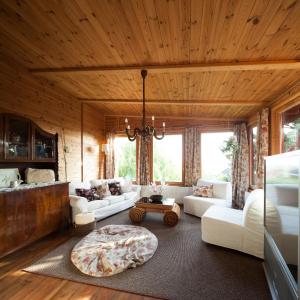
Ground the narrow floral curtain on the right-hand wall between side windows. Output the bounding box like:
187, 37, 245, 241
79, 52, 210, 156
256, 108, 269, 189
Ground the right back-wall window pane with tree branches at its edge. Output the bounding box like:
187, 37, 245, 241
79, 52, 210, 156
201, 132, 234, 181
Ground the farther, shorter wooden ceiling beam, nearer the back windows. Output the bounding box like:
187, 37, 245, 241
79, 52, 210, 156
79, 98, 264, 106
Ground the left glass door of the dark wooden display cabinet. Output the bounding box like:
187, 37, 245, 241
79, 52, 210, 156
5, 117, 30, 160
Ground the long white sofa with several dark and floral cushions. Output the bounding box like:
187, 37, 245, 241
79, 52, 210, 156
69, 179, 141, 222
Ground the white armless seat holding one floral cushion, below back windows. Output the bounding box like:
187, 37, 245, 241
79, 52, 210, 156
183, 179, 232, 217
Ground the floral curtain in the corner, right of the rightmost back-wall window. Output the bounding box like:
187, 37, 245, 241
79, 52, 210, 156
232, 123, 249, 209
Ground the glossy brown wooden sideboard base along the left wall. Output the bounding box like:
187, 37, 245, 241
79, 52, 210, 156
0, 183, 71, 257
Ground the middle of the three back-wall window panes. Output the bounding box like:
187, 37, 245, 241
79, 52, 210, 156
153, 134, 183, 182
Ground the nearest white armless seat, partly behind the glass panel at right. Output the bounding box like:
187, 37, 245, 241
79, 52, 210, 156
201, 189, 280, 258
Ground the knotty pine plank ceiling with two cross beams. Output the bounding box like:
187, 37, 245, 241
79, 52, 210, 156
0, 0, 300, 118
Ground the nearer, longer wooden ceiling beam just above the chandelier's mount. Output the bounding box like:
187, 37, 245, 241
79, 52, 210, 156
29, 60, 300, 75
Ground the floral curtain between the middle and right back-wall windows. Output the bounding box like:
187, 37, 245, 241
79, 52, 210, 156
184, 128, 201, 186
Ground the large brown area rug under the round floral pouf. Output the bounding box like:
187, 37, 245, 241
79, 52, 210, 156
25, 211, 271, 300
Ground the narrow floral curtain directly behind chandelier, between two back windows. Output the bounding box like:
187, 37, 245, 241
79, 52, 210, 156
137, 137, 150, 185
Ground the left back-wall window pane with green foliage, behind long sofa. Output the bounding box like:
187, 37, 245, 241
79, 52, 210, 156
114, 137, 136, 180
